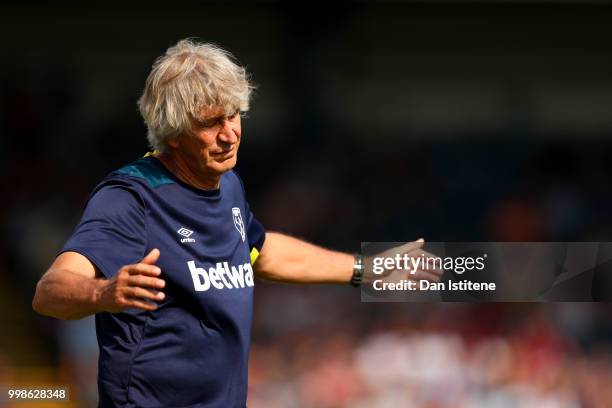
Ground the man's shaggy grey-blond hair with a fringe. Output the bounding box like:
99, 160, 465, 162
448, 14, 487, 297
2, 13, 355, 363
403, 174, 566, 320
138, 39, 254, 152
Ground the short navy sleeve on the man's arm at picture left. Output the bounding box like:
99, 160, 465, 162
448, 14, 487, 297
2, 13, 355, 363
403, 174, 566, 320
61, 185, 147, 278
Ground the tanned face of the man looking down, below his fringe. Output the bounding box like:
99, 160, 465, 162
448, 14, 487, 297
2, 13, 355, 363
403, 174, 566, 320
169, 107, 241, 177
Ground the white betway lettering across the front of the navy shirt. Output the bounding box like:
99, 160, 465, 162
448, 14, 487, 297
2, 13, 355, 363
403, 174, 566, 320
187, 261, 254, 292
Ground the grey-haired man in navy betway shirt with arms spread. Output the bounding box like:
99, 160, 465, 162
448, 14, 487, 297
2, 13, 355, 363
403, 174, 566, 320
33, 40, 437, 407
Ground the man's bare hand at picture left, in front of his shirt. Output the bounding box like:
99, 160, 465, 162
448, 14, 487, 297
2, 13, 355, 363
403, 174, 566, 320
96, 248, 166, 313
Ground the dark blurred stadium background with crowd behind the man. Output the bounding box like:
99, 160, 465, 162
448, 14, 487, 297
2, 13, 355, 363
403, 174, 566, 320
0, 1, 612, 408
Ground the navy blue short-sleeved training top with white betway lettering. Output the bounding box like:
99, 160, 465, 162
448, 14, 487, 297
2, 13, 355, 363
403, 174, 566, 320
62, 157, 265, 408
